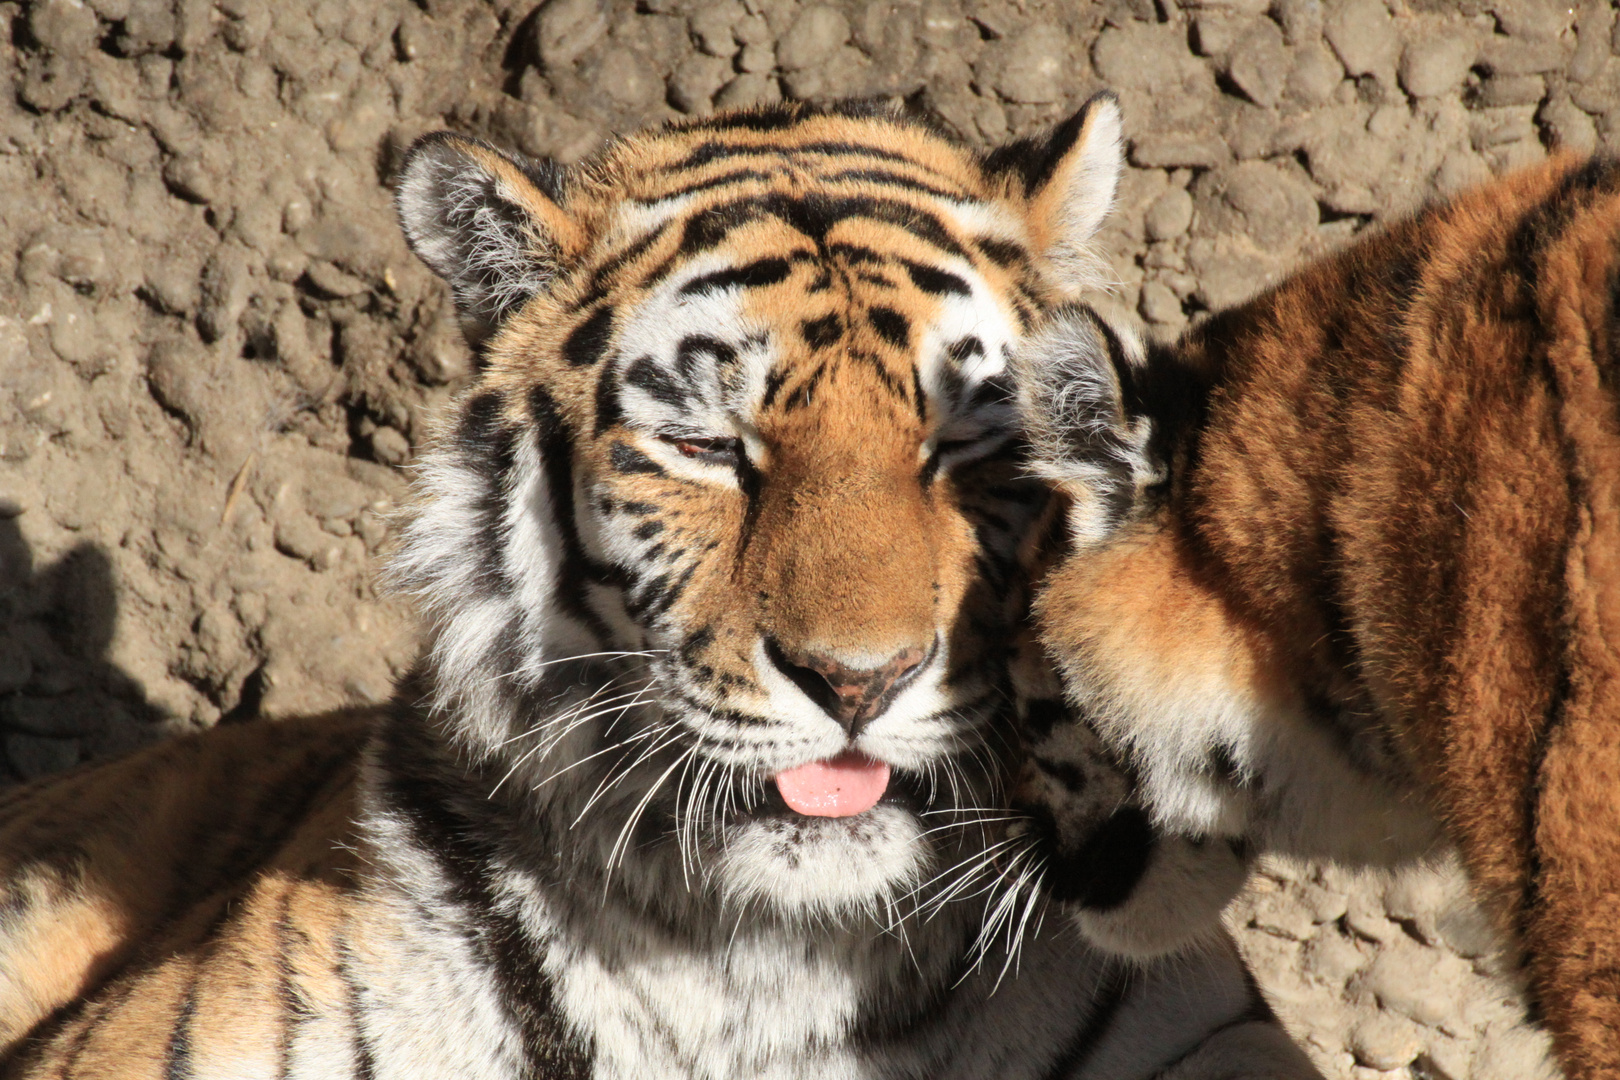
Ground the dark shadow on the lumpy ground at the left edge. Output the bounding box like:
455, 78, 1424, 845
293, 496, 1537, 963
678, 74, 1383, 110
0, 514, 160, 784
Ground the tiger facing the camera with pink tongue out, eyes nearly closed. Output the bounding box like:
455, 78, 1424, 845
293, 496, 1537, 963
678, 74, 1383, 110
0, 99, 1309, 1080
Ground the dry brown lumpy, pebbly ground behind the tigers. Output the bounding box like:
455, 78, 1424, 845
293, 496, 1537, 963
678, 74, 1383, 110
0, 0, 1600, 1080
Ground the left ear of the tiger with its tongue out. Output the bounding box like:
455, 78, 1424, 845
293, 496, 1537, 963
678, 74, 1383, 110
394, 131, 583, 348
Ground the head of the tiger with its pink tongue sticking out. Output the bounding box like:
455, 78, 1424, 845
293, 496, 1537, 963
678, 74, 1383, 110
397, 97, 1121, 918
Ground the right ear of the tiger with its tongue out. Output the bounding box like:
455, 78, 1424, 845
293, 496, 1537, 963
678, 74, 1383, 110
985, 91, 1124, 291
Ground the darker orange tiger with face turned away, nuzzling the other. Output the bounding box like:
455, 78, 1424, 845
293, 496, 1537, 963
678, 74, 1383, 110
1019, 159, 1620, 1078
